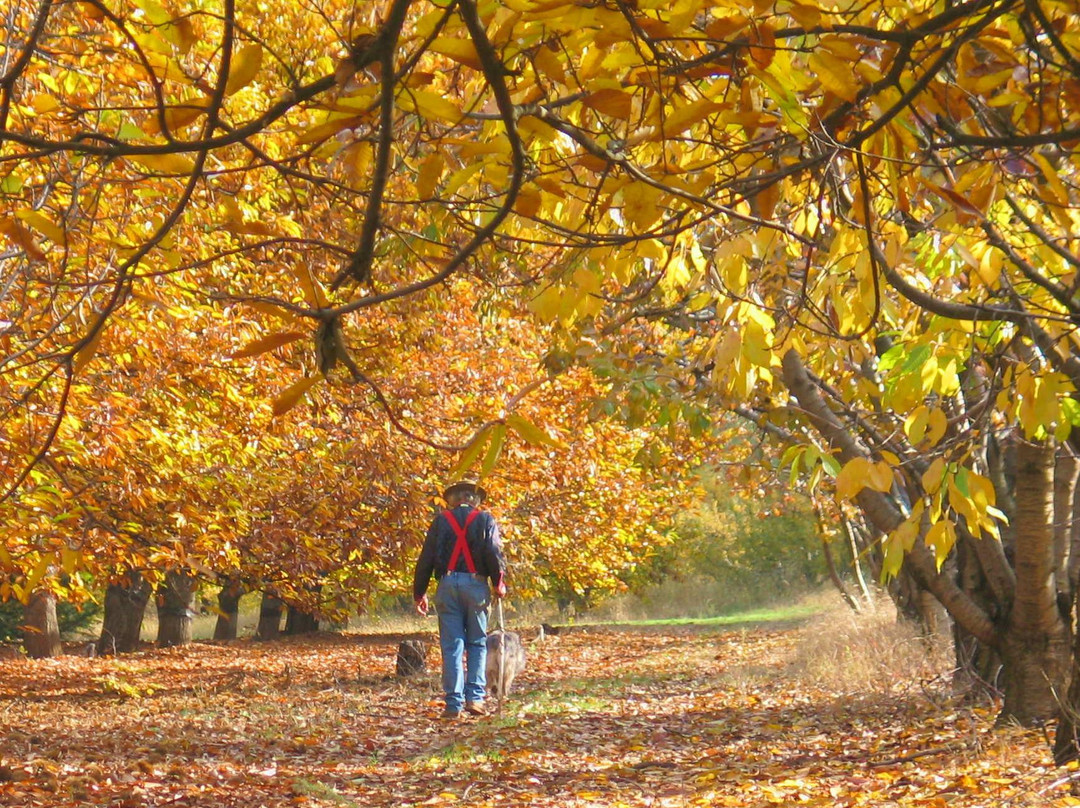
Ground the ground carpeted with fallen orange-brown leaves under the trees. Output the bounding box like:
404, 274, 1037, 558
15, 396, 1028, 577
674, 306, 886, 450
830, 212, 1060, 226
0, 630, 1080, 808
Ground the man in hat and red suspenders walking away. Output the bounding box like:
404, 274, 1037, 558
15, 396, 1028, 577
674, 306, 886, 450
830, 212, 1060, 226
413, 482, 507, 718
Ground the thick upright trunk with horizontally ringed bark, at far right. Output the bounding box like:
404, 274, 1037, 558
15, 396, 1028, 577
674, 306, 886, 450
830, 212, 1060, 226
999, 441, 1069, 726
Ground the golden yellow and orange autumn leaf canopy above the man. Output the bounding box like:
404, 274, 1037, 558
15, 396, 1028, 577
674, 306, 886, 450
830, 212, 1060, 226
6, 0, 1080, 661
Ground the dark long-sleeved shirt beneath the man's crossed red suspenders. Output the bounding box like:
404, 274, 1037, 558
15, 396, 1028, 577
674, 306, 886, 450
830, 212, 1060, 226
413, 504, 507, 600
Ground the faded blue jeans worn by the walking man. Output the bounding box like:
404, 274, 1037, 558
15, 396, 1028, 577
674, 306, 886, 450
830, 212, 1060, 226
435, 573, 491, 710
